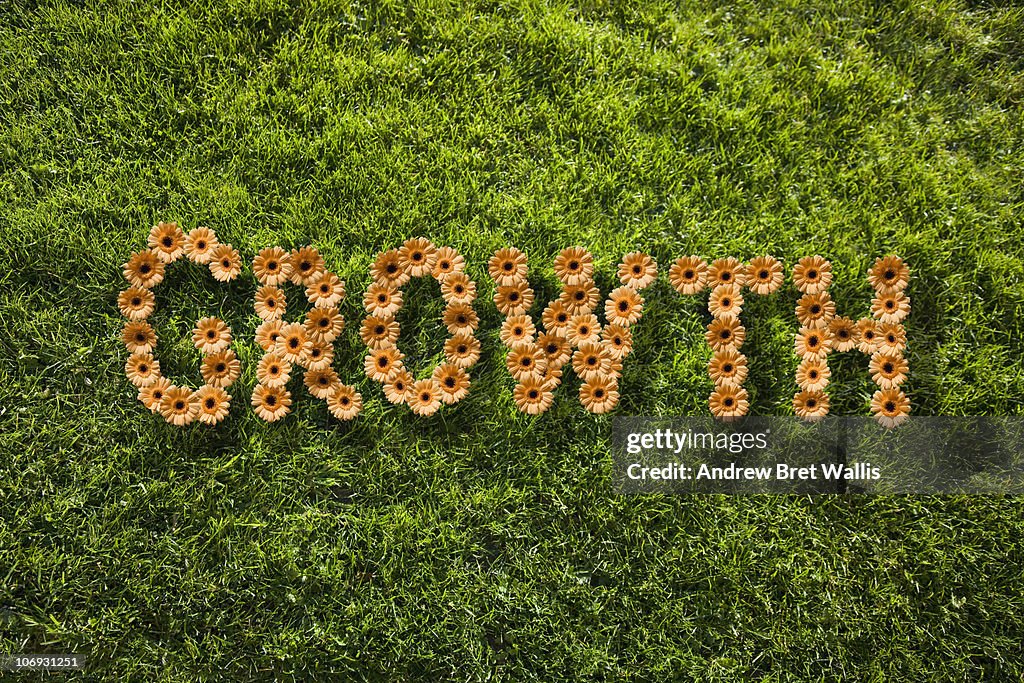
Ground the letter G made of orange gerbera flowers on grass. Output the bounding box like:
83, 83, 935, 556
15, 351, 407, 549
118, 222, 242, 427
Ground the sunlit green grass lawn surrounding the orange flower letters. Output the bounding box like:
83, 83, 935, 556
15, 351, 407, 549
0, 0, 1024, 681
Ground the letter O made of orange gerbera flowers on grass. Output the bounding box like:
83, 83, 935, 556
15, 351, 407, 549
359, 238, 480, 417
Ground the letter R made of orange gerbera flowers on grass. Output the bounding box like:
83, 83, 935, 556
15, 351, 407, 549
252, 242, 362, 422
